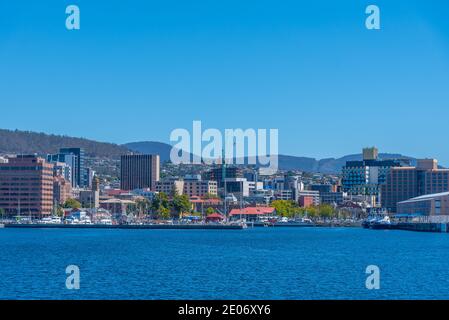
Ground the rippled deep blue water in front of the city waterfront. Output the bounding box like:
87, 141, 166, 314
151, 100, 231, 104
0, 228, 449, 299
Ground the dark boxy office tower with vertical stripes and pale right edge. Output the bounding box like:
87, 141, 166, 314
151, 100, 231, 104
120, 154, 160, 190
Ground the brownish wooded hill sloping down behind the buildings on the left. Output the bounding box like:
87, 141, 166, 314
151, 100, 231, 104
0, 129, 129, 159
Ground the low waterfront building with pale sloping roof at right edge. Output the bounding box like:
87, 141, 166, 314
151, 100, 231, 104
397, 192, 449, 216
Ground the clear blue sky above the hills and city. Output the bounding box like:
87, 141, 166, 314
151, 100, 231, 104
0, 0, 449, 165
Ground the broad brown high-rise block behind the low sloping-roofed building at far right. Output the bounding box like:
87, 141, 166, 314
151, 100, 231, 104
382, 159, 449, 212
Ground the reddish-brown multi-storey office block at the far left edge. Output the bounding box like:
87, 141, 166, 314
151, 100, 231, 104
0, 155, 53, 217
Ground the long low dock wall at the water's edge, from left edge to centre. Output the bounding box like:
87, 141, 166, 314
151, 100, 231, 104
4, 223, 245, 230
